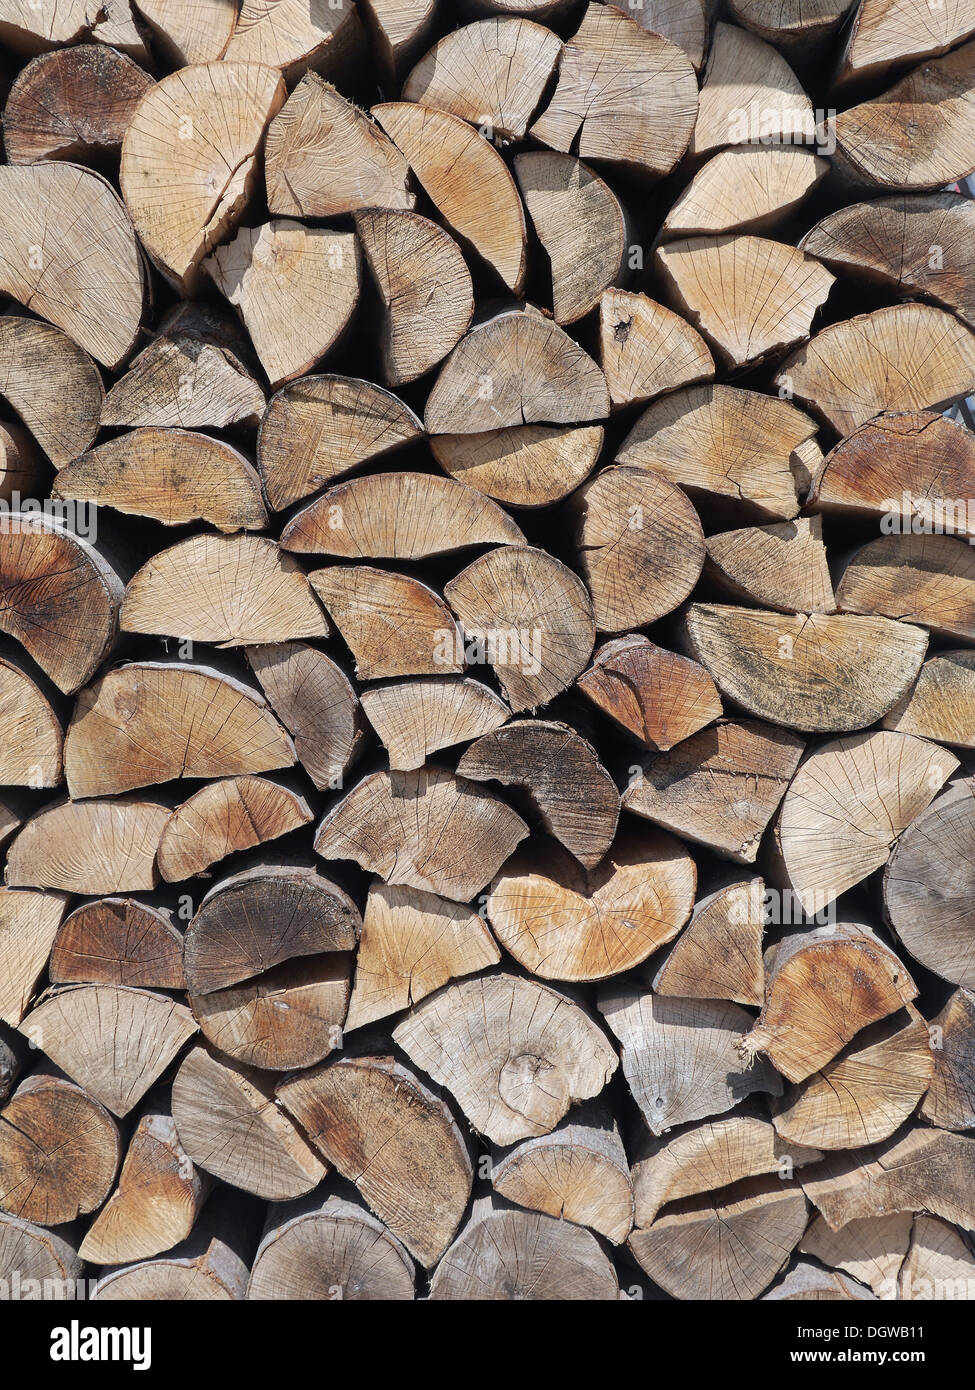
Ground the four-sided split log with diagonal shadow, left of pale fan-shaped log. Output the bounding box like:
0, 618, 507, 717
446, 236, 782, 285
623, 720, 803, 865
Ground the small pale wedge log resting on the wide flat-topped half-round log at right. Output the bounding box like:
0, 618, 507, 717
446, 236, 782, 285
704, 516, 834, 617
